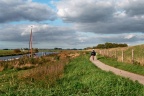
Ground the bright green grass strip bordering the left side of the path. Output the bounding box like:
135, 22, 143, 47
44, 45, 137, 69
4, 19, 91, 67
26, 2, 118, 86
48, 55, 144, 96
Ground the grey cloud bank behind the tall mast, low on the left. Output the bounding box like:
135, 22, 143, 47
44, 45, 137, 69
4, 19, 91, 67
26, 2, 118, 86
0, 24, 84, 46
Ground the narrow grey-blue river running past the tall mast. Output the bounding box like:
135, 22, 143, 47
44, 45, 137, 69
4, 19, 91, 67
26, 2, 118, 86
0, 52, 54, 61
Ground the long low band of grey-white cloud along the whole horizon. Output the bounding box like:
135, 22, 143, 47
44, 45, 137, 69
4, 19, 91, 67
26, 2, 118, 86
0, 24, 144, 48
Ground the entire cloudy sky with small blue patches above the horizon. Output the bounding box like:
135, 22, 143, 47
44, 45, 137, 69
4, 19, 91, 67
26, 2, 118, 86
0, 0, 144, 49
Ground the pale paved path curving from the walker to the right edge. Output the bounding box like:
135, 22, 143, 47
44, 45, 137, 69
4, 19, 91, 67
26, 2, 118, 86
90, 58, 144, 85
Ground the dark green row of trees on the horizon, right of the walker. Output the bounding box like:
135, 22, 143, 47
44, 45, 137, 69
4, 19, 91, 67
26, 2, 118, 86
93, 42, 128, 49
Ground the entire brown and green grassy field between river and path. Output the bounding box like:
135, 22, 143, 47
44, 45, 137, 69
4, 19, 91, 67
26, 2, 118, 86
0, 52, 144, 96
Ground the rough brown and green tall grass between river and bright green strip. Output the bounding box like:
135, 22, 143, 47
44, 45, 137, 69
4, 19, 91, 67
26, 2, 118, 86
0, 52, 79, 96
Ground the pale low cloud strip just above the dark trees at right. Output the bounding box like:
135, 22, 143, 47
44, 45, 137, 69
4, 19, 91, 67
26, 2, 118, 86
85, 33, 144, 46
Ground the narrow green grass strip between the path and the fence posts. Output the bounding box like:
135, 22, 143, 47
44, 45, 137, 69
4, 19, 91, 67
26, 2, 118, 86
98, 56, 144, 75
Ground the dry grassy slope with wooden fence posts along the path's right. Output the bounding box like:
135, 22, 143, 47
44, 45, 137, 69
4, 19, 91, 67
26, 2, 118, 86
96, 47, 144, 66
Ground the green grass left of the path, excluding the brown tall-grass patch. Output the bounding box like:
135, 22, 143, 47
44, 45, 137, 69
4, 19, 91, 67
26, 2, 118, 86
0, 52, 144, 96
